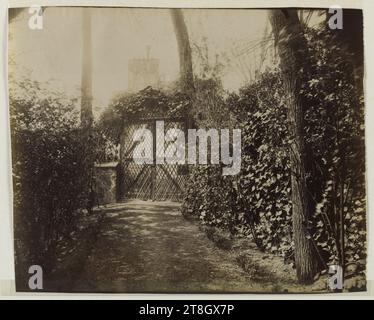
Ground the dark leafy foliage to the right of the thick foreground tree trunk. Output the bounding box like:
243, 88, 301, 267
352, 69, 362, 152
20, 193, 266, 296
302, 30, 366, 265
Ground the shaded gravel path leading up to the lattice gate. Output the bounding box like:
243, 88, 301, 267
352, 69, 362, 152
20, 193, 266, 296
72, 200, 271, 293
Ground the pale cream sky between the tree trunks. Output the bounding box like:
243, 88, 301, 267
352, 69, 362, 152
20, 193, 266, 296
9, 7, 269, 115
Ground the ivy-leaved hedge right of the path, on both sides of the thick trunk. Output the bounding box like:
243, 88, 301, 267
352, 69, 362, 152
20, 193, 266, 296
183, 30, 366, 278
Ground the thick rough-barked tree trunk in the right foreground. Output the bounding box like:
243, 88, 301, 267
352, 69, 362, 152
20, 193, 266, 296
270, 9, 318, 283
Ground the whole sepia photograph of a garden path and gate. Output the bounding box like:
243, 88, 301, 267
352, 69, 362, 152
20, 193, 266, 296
8, 5, 367, 296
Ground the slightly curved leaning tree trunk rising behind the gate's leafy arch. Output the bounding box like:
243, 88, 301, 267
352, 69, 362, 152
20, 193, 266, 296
170, 9, 195, 95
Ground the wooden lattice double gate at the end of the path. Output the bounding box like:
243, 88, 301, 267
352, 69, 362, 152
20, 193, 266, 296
120, 118, 187, 201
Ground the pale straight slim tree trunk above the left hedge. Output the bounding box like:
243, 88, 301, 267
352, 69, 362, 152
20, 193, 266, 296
81, 8, 93, 131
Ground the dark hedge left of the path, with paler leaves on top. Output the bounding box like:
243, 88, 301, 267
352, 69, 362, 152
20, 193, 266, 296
10, 80, 90, 275
